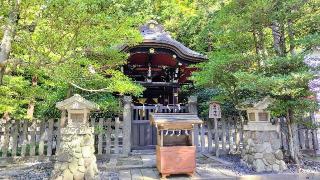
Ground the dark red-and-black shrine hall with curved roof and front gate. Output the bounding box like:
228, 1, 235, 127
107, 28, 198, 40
120, 21, 206, 150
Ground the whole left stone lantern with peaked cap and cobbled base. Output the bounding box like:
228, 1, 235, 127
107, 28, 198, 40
51, 94, 98, 179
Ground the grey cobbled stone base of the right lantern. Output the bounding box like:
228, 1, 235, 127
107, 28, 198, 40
242, 125, 287, 172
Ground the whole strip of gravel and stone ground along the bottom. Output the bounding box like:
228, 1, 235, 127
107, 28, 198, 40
0, 153, 320, 180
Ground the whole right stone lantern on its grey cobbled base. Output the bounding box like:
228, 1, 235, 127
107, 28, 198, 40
240, 97, 287, 172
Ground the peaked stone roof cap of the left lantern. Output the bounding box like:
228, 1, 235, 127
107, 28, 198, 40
56, 94, 99, 110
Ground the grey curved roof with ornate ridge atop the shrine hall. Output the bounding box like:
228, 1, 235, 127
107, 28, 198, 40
120, 20, 207, 62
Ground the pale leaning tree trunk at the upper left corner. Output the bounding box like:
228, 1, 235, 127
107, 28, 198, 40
0, 0, 20, 85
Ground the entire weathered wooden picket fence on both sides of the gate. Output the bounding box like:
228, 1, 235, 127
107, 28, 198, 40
0, 117, 319, 163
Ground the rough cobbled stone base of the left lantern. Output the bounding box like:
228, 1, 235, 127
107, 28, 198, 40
51, 127, 98, 180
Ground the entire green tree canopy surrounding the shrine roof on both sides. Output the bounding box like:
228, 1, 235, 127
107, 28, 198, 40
0, 0, 320, 124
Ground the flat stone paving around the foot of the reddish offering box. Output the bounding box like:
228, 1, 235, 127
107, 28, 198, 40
100, 154, 237, 180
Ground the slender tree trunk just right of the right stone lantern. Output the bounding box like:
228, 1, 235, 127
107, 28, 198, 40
286, 109, 300, 166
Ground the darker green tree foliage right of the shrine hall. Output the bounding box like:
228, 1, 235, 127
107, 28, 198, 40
193, 0, 320, 119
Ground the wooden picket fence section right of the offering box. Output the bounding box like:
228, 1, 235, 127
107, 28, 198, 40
195, 117, 319, 157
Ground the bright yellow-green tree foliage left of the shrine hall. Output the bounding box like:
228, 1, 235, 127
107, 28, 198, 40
0, 0, 143, 119
